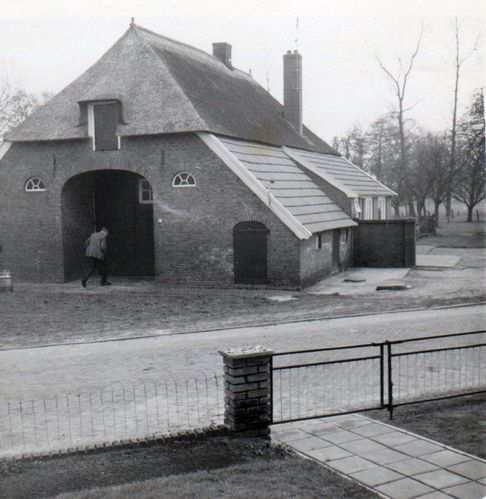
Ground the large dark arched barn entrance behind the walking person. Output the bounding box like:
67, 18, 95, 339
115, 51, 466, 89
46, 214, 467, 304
62, 170, 154, 280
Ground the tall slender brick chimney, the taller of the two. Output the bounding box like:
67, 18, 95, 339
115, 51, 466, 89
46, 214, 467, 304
284, 50, 302, 135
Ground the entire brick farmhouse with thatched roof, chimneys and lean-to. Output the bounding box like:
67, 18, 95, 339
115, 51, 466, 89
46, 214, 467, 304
0, 23, 394, 286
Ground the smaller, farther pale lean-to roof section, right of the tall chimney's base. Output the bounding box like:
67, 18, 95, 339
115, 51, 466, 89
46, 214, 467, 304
285, 147, 395, 197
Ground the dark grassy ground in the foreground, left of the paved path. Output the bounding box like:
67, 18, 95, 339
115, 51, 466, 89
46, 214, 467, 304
0, 436, 375, 499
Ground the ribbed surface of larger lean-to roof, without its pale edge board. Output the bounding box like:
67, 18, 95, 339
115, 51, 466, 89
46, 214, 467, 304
218, 137, 356, 232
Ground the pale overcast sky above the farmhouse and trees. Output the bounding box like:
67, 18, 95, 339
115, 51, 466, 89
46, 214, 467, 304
0, 0, 486, 141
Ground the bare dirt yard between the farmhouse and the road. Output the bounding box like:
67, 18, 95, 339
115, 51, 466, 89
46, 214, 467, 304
0, 222, 486, 348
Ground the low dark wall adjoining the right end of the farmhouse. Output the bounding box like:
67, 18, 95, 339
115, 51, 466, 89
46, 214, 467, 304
354, 219, 415, 267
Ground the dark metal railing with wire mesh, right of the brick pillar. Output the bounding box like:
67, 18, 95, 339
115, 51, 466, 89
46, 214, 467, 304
271, 331, 486, 424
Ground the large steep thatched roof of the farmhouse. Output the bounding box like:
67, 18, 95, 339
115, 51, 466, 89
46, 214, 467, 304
7, 25, 335, 154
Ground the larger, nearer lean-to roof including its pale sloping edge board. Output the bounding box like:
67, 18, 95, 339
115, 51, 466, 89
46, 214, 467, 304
200, 134, 356, 239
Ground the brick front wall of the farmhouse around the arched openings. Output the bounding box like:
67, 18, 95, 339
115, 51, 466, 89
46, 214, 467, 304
0, 134, 301, 286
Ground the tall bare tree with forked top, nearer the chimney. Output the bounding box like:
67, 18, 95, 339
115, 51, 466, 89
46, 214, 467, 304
378, 25, 423, 215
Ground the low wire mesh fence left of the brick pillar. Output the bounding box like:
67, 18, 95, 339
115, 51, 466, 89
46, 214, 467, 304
0, 375, 224, 456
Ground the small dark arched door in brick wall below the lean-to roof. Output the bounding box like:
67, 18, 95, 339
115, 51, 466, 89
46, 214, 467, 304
233, 222, 269, 284
